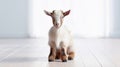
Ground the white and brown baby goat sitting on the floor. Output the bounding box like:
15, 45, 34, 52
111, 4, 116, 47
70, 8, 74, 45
44, 10, 74, 62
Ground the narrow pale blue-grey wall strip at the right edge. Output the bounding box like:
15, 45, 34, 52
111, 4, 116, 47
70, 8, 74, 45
110, 0, 120, 37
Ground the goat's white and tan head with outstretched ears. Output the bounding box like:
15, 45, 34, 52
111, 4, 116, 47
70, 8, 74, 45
44, 10, 70, 28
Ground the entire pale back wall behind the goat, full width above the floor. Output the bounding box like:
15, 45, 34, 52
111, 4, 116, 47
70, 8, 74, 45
0, 0, 120, 37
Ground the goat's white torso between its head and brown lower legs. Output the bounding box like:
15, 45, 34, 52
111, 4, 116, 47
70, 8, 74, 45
49, 26, 73, 51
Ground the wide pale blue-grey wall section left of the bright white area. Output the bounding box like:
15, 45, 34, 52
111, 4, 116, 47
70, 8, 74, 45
0, 0, 29, 37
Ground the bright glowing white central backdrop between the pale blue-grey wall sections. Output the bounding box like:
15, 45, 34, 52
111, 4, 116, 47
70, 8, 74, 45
29, 0, 113, 37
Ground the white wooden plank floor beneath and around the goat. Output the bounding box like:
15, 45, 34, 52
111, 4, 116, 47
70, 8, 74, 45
0, 38, 120, 67
